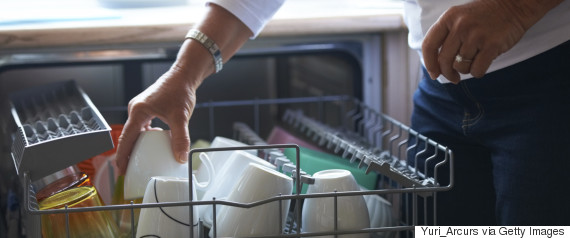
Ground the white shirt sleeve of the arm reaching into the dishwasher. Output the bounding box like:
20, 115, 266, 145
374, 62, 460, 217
206, 0, 285, 38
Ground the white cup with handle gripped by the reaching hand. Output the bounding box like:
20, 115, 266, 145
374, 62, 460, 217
124, 130, 215, 200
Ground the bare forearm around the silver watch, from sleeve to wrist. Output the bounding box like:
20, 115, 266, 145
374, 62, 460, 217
172, 4, 253, 90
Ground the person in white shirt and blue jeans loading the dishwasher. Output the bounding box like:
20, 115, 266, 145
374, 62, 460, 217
117, 0, 570, 225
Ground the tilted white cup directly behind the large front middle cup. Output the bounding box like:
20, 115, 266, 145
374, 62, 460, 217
199, 150, 276, 227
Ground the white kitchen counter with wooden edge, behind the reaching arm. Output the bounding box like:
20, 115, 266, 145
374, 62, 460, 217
0, 0, 405, 53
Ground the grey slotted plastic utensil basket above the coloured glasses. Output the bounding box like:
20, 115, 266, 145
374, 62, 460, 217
10, 80, 113, 180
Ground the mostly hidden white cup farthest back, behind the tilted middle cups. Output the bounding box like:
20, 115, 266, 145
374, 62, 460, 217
192, 136, 257, 185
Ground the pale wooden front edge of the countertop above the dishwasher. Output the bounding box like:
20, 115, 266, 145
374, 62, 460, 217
0, 13, 406, 52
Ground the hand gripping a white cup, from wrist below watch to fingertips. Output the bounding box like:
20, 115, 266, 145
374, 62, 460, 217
116, 65, 196, 174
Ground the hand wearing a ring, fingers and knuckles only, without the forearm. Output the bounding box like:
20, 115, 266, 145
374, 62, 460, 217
422, 2, 504, 83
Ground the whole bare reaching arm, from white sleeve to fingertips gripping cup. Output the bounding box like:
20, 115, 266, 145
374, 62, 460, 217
112, 4, 258, 174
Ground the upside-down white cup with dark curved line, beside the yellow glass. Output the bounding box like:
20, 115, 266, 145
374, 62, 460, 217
136, 176, 199, 237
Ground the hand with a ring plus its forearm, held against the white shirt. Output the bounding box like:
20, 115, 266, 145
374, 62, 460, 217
422, 0, 561, 83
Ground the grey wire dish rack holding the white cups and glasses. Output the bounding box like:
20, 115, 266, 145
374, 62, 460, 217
18, 96, 453, 237
